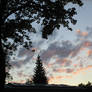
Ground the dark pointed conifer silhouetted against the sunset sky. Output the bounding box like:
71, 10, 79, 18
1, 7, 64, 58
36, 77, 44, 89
32, 55, 48, 84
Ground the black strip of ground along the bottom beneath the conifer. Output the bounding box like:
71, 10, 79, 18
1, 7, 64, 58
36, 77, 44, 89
4, 85, 92, 92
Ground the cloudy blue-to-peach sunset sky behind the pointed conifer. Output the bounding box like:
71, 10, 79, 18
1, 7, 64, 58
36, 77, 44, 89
7, 0, 92, 85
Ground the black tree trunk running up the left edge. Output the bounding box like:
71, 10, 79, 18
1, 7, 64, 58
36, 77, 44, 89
0, 0, 7, 88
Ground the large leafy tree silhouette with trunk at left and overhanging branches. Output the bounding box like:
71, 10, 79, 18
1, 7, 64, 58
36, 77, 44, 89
0, 0, 83, 87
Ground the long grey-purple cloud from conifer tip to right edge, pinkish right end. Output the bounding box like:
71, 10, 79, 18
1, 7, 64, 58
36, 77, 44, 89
41, 40, 92, 60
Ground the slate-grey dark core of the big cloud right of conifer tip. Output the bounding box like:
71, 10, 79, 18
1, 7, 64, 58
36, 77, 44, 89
41, 41, 73, 60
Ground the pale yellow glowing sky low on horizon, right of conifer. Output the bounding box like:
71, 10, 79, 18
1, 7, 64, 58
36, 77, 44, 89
49, 66, 92, 86
